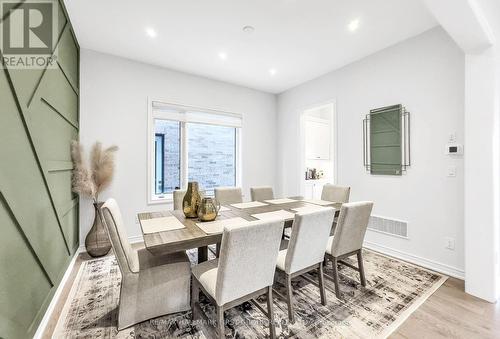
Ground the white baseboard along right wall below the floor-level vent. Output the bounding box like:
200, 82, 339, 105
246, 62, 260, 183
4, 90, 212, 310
363, 241, 465, 280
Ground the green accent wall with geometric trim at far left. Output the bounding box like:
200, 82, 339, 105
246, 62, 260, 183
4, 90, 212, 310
0, 0, 79, 339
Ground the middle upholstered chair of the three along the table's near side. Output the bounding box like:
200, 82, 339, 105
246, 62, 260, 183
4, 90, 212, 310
275, 207, 335, 323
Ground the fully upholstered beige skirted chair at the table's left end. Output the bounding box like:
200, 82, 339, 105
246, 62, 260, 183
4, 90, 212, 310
100, 199, 191, 330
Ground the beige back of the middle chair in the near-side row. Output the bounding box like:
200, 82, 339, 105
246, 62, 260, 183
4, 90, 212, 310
285, 207, 335, 274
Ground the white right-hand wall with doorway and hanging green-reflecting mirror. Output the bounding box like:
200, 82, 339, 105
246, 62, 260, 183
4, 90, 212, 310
278, 28, 467, 276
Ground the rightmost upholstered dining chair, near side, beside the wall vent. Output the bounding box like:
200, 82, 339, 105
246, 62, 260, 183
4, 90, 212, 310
325, 201, 373, 299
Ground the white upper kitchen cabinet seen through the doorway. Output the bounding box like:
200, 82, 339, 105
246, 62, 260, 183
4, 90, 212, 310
305, 118, 331, 160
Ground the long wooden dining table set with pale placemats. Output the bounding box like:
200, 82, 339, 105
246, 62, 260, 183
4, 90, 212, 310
138, 196, 342, 263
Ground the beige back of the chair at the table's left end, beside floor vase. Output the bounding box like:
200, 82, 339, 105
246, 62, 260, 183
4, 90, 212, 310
101, 199, 139, 274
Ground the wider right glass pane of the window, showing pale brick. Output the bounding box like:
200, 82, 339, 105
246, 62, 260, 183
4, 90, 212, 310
186, 123, 236, 195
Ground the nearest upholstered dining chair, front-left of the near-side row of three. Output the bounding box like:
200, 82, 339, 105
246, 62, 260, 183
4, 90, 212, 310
191, 220, 284, 338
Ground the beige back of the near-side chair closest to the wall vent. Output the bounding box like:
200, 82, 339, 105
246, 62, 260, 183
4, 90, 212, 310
331, 201, 373, 257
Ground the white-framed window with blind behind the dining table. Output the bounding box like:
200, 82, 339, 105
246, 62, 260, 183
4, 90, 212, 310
148, 101, 241, 203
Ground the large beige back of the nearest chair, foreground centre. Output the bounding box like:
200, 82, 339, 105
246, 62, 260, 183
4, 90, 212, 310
215, 220, 284, 305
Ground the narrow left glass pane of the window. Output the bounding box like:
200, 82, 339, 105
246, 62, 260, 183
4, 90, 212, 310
155, 119, 181, 194
